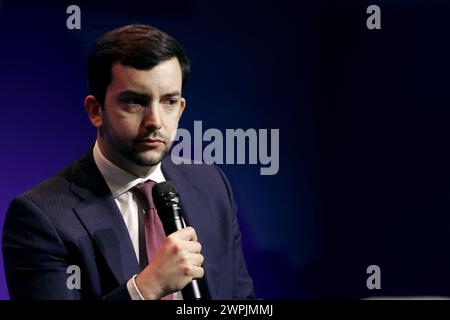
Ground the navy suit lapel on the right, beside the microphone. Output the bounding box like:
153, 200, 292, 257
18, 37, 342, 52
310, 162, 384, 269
161, 156, 216, 298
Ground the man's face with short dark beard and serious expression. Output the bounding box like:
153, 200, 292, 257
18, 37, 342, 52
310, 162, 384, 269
100, 58, 186, 166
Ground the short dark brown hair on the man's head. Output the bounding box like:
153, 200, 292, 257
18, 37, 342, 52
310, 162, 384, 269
86, 24, 190, 106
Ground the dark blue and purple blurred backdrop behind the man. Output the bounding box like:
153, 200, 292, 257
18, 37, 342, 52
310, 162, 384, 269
0, 0, 450, 299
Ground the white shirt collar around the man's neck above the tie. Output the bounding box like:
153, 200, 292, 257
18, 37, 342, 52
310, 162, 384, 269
93, 141, 166, 198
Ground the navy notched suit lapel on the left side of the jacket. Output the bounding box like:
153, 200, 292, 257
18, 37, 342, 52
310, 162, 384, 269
71, 148, 139, 284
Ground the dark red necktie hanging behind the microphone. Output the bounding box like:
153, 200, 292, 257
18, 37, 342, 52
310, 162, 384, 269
134, 180, 173, 300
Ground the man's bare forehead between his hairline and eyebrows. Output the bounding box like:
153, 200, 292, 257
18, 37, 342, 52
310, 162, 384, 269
108, 58, 182, 94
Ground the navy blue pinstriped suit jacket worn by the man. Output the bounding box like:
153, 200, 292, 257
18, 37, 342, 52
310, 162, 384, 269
3, 148, 254, 299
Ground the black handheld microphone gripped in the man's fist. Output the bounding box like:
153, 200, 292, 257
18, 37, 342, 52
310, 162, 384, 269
152, 181, 205, 300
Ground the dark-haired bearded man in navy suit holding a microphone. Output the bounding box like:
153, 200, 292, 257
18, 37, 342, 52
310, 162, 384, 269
3, 25, 254, 299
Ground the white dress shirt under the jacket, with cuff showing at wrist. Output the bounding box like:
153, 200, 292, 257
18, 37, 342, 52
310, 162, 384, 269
93, 142, 182, 300
